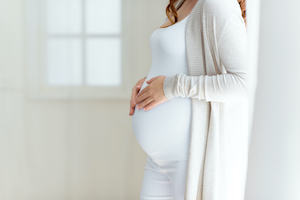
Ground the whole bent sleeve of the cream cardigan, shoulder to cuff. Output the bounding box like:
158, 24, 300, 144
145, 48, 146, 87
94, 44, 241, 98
163, 14, 247, 102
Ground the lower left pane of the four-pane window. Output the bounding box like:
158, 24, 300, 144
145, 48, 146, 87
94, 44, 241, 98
47, 38, 82, 85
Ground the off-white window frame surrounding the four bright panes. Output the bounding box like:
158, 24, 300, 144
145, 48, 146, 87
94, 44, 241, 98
25, 0, 132, 99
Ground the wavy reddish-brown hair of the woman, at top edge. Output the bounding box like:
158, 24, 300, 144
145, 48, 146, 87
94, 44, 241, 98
164, 0, 247, 28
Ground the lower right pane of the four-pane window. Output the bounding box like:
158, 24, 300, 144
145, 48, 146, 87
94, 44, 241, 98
86, 38, 121, 86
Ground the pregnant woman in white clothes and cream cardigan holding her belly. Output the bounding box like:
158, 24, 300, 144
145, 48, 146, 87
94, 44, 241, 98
129, 0, 248, 200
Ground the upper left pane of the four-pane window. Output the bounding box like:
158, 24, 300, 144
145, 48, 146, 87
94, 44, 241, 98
46, 0, 82, 34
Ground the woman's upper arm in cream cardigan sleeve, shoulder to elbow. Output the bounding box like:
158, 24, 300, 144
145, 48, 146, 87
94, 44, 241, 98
204, 0, 248, 83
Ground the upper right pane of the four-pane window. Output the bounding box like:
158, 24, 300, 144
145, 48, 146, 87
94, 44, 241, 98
85, 0, 121, 34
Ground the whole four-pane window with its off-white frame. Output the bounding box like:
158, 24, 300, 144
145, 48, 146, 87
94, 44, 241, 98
27, 0, 131, 98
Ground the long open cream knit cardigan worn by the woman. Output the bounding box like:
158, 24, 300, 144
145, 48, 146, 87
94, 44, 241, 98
163, 0, 249, 200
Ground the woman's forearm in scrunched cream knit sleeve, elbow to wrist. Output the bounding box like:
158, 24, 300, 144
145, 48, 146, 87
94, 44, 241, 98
163, 73, 248, 102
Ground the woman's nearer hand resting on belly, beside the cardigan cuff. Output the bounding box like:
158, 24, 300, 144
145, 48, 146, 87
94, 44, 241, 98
135, 75, 168, 110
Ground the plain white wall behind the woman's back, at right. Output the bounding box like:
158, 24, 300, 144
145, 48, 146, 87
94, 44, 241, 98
246, 0, 300, 200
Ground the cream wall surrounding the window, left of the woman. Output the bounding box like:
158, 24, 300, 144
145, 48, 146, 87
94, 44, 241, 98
0, 0, 166, 200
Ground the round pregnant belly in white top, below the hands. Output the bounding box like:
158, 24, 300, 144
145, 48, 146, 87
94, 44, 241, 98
132, 83, 192, 160
